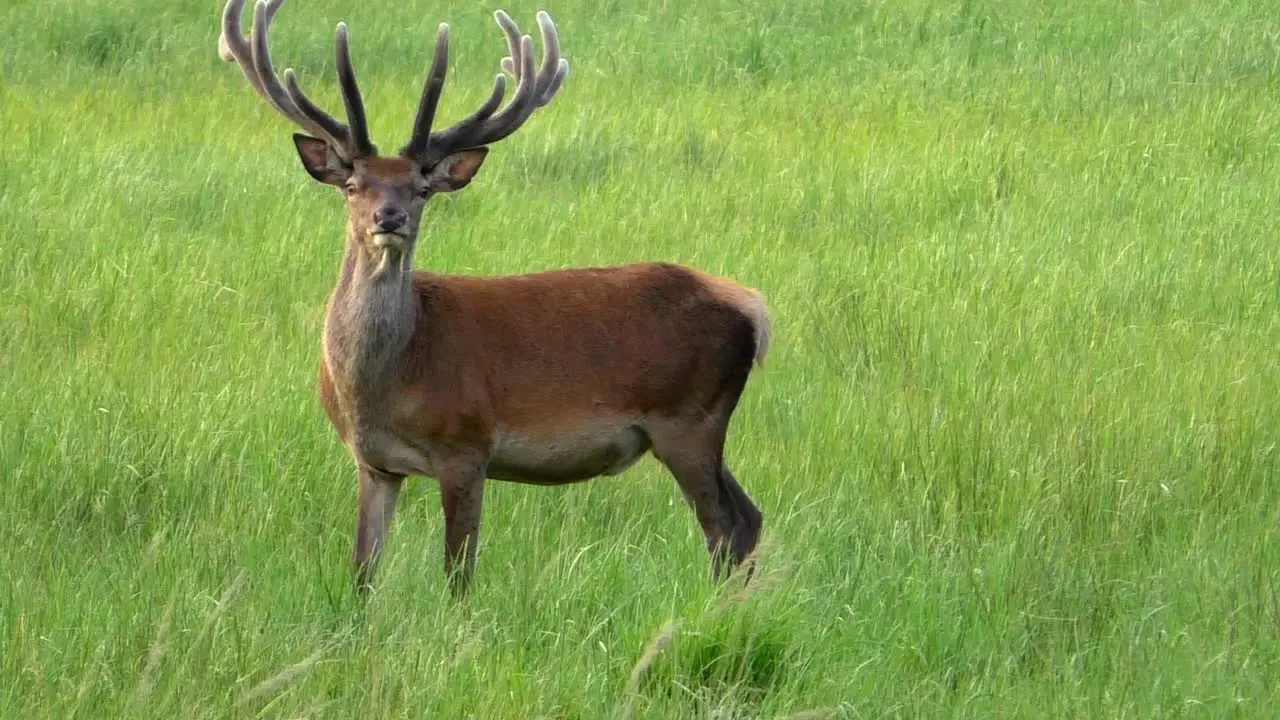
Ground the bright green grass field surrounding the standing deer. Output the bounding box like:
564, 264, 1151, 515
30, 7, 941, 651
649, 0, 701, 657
0, 0, 1280, 719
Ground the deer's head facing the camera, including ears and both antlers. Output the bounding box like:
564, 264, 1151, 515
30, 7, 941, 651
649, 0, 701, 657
219, 0, 568, 256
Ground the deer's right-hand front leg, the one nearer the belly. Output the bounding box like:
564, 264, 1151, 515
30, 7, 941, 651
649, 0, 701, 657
439, 459, 485, 597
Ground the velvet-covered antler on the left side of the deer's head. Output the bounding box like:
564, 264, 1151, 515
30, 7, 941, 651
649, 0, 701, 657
218, 0, 378, 164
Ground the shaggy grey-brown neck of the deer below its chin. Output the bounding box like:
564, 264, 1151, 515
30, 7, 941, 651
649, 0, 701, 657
324, 237, 417, 392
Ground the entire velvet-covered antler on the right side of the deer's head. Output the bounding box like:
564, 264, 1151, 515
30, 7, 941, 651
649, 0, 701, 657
404, 10, 568, 167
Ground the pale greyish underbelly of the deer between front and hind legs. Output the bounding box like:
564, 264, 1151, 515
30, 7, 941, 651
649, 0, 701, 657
489, 423, 650, 484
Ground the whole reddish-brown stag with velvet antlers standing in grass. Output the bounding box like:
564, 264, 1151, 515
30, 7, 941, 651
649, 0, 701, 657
219, 0, 771, 598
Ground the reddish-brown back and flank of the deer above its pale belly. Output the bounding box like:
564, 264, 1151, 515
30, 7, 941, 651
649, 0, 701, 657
415, 263, 759, 425
